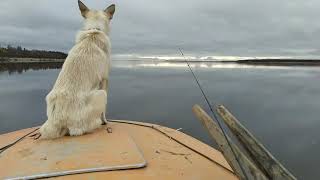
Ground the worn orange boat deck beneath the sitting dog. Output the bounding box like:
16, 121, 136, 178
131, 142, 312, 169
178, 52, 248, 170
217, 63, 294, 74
0, 120, 237, 180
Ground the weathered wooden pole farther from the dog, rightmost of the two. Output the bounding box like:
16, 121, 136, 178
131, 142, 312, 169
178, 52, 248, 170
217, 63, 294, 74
217, 105, 296, 180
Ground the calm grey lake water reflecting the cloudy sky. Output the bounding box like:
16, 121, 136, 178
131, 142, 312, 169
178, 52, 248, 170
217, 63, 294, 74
0, 61, 320, 179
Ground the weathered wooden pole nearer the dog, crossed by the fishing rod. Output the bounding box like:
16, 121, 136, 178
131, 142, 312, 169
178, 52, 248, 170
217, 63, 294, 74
192, 105, 267, 180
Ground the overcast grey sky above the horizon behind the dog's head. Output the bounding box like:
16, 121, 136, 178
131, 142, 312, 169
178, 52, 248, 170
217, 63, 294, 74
0, 0, 320, 56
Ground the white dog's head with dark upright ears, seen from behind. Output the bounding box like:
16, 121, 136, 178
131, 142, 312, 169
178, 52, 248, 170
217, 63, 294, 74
78, 0, 116, 34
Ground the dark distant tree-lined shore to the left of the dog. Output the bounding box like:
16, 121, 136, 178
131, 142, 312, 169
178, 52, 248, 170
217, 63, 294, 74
0, 45, 67, 59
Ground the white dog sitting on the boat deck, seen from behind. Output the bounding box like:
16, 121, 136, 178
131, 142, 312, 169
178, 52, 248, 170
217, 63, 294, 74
39, 0, 115, 139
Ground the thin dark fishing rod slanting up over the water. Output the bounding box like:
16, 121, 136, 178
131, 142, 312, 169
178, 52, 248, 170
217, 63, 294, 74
179, 48, 249, 179
